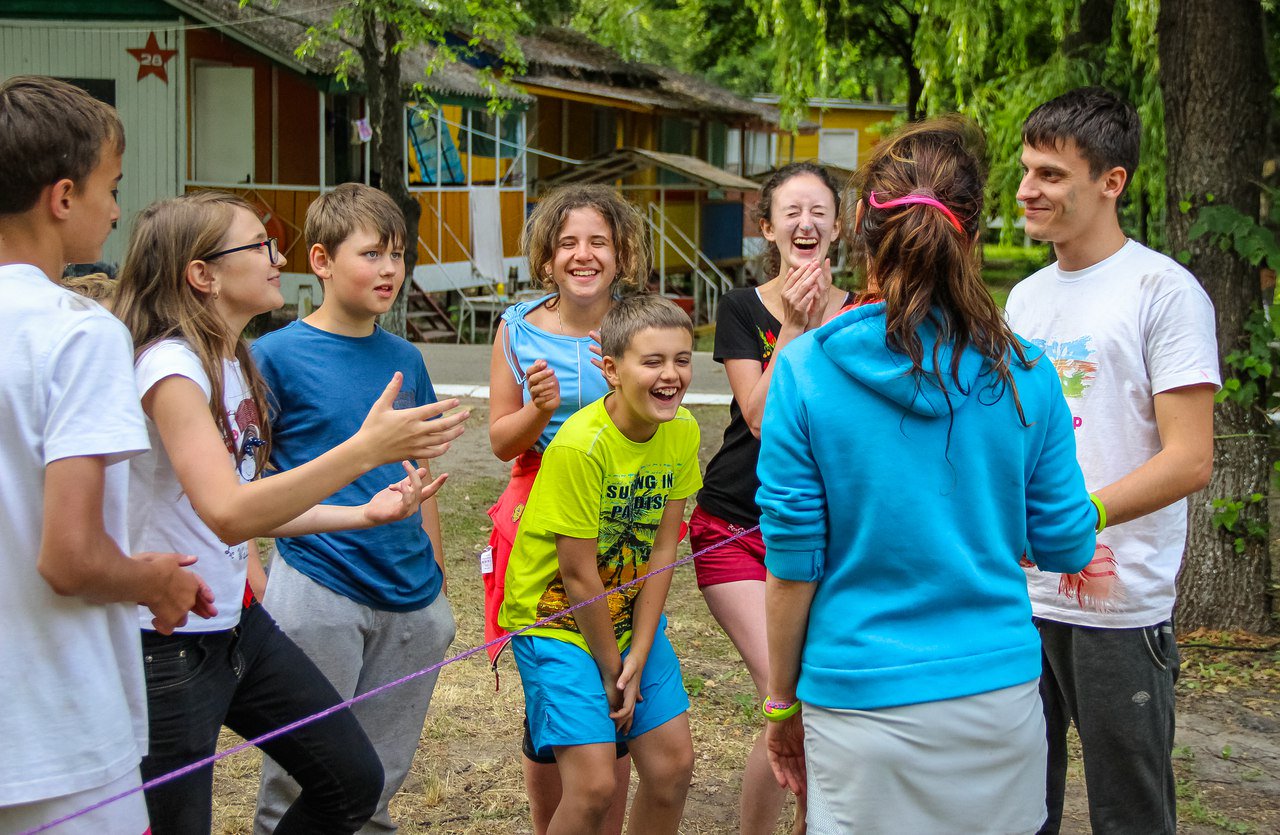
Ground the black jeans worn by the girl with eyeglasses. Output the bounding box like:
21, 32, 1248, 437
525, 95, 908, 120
142, 603, 383, 835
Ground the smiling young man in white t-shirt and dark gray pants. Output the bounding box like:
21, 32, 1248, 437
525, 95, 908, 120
1007, 88, 1221, 835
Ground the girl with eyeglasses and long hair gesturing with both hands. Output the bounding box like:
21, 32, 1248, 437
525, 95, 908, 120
115, 192, 466, 835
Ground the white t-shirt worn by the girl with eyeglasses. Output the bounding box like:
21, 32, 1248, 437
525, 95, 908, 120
129, 339, 261, 633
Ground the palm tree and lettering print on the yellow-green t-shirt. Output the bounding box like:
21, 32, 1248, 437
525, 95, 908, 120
536, 464, 676, 639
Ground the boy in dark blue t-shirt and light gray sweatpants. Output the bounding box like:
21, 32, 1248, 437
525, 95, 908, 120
253, 183, 454, 832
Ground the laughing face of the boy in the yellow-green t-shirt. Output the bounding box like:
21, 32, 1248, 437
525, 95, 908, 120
604, 328, 694, 442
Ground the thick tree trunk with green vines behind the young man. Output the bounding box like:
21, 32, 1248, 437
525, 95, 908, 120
1157, 0, 1272, 631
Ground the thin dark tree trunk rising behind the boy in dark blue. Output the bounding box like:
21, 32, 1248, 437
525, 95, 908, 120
358, 10, 422, 337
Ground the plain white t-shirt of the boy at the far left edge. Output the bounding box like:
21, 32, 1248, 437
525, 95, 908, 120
0, 264, 147, 806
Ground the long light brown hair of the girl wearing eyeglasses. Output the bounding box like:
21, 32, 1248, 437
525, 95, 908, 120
113, 191, 271, 478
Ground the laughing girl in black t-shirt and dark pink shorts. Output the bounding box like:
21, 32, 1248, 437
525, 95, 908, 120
689, 163, 849, 835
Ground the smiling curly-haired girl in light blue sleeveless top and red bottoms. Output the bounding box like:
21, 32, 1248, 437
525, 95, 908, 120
481, 186, 649, 835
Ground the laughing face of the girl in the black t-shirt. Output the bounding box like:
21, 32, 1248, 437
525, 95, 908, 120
760, 173, 840, 274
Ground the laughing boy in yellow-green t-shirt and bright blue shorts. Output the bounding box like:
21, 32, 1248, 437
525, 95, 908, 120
498, 295, 701, 832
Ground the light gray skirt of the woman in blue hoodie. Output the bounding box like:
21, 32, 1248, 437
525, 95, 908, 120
803, 681, 1047, 835
